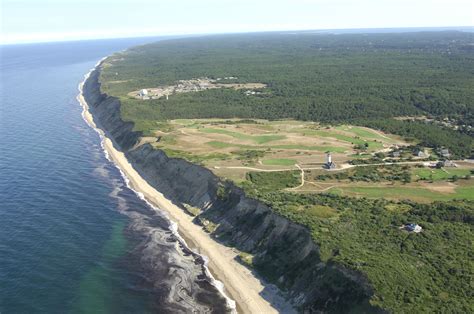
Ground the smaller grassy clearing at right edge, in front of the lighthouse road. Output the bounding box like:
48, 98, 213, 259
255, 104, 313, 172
288, 163, 474, 203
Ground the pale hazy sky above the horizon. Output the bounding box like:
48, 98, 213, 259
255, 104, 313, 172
0, 0, 474, 43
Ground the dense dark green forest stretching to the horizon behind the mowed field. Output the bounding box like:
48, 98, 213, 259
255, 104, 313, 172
101, 32, 474, 157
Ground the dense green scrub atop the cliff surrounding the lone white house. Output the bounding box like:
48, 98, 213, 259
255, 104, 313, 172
244, 184, 474, 313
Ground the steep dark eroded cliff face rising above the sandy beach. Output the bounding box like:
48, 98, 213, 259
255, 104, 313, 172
84, 70, 379, 312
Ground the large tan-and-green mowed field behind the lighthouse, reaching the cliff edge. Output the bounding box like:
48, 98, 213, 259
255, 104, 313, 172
135, 119, 408, 181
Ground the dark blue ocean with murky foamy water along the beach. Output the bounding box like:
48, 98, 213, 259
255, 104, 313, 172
0, 38, 230, 313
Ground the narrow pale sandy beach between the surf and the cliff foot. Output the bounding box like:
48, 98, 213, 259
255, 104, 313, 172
77, 58, 293, 313
